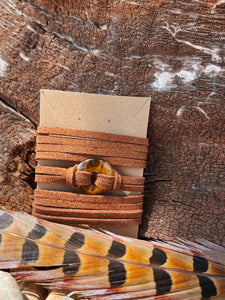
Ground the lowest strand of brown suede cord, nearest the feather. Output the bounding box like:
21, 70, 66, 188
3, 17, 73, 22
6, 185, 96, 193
33, 209, 141, 226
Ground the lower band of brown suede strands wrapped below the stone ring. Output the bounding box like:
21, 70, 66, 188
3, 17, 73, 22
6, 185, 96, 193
33, 189, 142, 225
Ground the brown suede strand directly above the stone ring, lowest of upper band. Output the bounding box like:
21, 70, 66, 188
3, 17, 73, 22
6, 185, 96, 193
36, 152, 146, 168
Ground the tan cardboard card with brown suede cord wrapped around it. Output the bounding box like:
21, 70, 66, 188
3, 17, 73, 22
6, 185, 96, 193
38, 90, 151, 237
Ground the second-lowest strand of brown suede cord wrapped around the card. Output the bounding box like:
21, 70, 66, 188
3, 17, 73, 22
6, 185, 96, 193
33, 204, 142, 219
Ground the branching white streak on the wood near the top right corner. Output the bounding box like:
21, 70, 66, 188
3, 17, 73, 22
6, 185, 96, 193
161, 22, 222, 62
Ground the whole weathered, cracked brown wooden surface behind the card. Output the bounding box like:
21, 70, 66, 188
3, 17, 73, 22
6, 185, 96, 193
0, 0, 225, 243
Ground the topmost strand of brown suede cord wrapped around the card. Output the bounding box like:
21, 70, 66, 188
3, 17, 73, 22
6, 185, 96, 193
37, 126, 148, 146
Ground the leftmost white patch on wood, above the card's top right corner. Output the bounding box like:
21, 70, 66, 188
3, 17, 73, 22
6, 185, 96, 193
152, 71, 176, 91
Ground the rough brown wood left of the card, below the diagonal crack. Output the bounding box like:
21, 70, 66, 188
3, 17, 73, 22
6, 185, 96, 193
0, 101, 35, 213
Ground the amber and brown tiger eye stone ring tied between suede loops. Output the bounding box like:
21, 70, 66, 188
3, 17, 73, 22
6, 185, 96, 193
77, 158, 113, 195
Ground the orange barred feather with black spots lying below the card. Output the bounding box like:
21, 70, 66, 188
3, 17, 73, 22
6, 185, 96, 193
0, 210, 225, 300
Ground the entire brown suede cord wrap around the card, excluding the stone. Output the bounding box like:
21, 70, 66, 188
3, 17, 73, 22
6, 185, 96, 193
33, 126, 148, 225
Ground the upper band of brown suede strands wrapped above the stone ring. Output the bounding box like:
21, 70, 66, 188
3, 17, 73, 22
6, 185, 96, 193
36, 126, 148, 168
